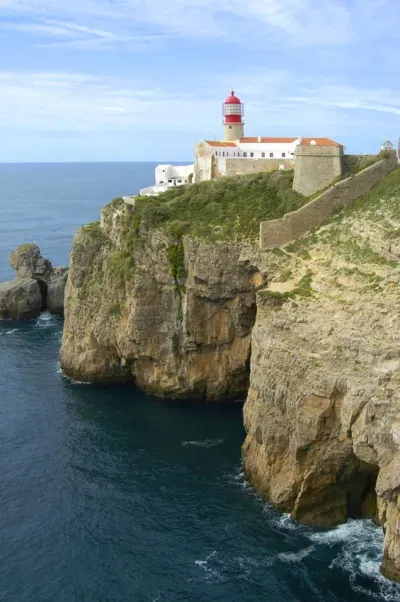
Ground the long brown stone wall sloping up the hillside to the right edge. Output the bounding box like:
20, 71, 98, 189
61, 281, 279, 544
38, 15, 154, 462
260, 153, 398, 249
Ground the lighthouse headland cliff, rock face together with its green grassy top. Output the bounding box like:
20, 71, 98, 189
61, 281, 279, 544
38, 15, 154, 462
61, 169, 303, 400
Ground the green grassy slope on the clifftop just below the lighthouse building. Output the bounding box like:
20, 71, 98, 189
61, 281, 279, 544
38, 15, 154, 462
128, 171, 308, 241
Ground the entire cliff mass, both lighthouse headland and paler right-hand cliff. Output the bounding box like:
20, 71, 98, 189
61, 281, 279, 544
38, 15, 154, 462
61, 170, 400, 580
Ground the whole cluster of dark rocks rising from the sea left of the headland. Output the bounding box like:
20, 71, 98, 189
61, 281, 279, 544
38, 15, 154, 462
0, 243, 68, 320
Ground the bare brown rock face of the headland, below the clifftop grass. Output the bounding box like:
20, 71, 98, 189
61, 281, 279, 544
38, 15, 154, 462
57, 203, 262, 400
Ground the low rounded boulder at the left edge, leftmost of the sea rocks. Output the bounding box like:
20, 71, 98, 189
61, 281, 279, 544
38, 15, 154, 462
0, 278, 43, 320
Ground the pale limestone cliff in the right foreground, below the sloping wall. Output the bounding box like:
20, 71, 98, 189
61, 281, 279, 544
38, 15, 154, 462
243, 170, 400, 580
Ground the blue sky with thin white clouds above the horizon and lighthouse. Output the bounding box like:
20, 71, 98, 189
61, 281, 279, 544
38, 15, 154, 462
0, 0, 400, 161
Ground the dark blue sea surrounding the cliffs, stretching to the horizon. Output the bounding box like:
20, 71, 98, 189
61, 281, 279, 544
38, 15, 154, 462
0, 163, 400, 602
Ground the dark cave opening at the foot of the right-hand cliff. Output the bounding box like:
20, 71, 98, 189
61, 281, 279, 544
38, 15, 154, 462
347, 463, 378, 519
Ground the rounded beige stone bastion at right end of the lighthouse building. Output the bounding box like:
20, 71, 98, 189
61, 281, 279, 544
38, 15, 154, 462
293, 144, 343, 196
